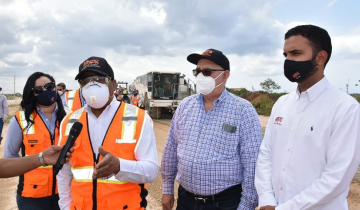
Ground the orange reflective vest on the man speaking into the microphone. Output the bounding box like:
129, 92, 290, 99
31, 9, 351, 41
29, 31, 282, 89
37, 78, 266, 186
60, 103, 147, 210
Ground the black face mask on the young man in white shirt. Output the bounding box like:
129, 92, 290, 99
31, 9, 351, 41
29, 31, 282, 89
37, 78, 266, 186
284, 56, 316, 82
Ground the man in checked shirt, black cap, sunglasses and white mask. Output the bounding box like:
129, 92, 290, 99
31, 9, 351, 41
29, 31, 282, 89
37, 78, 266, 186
161, 49, 262, 210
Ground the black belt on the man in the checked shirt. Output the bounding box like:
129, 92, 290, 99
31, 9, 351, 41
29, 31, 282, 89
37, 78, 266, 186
179, 184, 241, 203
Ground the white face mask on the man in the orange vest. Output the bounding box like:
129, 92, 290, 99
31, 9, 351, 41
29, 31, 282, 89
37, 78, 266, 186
81, 81, 109, 109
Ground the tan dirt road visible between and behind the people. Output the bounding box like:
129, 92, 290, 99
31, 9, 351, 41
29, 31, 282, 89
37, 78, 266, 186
0, 101, 360, 210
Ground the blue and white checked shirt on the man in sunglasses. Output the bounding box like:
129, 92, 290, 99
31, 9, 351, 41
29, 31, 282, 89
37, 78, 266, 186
161, 90, 262, 210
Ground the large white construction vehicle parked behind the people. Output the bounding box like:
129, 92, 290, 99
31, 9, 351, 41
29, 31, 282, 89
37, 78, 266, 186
129, 71, 196, 119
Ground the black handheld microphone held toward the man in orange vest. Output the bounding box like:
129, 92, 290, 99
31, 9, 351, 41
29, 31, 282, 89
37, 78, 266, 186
54, 122, 82, 176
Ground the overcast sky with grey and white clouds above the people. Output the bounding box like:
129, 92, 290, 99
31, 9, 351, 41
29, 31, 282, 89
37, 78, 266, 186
0, 0, 360, 93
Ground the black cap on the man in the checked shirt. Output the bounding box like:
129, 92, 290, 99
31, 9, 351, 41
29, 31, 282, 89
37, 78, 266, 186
187, 49, 230, 70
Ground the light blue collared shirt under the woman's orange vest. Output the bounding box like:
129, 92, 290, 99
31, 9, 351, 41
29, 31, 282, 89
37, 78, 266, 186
4, 104, 58, 158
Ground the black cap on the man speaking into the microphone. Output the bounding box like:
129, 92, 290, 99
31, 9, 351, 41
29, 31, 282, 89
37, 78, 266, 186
75, 56, 114, 80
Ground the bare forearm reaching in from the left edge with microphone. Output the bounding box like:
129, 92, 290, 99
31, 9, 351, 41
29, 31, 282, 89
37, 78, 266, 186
0, 154, 40, 178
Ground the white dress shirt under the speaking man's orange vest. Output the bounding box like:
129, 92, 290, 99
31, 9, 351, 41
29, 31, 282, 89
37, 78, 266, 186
57, 98, 158, 210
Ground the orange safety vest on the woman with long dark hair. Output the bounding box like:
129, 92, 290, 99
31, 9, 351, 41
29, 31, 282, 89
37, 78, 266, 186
15, 111, 59, 198
